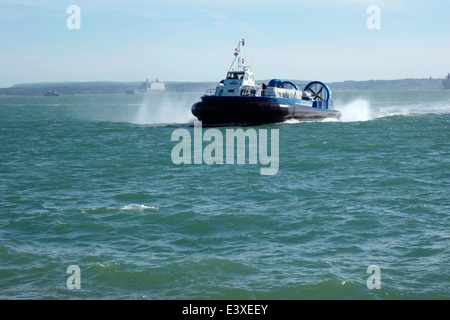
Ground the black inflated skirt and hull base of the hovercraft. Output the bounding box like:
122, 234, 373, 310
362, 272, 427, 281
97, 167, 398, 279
192, 96, 341, 125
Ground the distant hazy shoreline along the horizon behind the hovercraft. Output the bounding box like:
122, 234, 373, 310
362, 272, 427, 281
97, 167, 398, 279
0, 78, 445, 96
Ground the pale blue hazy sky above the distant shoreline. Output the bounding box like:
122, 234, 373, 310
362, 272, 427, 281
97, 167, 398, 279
0, 0, 450, 87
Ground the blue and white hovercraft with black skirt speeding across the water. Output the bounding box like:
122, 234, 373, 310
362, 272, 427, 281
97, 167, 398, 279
192, 39, 341, 125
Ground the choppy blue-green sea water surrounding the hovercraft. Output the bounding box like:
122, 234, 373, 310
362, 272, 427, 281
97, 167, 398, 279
0, 90, 450, 300
